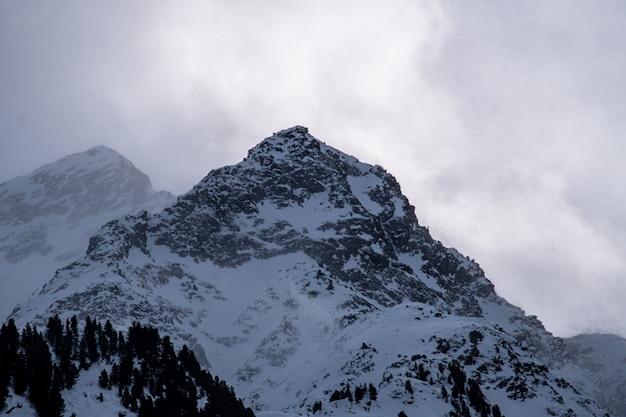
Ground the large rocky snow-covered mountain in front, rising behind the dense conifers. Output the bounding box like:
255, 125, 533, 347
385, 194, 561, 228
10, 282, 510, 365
2, 126, 616, 417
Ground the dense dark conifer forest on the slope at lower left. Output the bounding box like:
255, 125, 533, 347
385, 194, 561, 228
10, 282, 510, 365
0, 316, 254, 417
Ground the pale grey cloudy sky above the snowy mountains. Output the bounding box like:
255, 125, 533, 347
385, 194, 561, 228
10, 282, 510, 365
0, 0, 626, 336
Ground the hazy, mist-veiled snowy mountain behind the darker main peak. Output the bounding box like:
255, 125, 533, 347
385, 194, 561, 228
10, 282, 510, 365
0, 146, 174, 318
